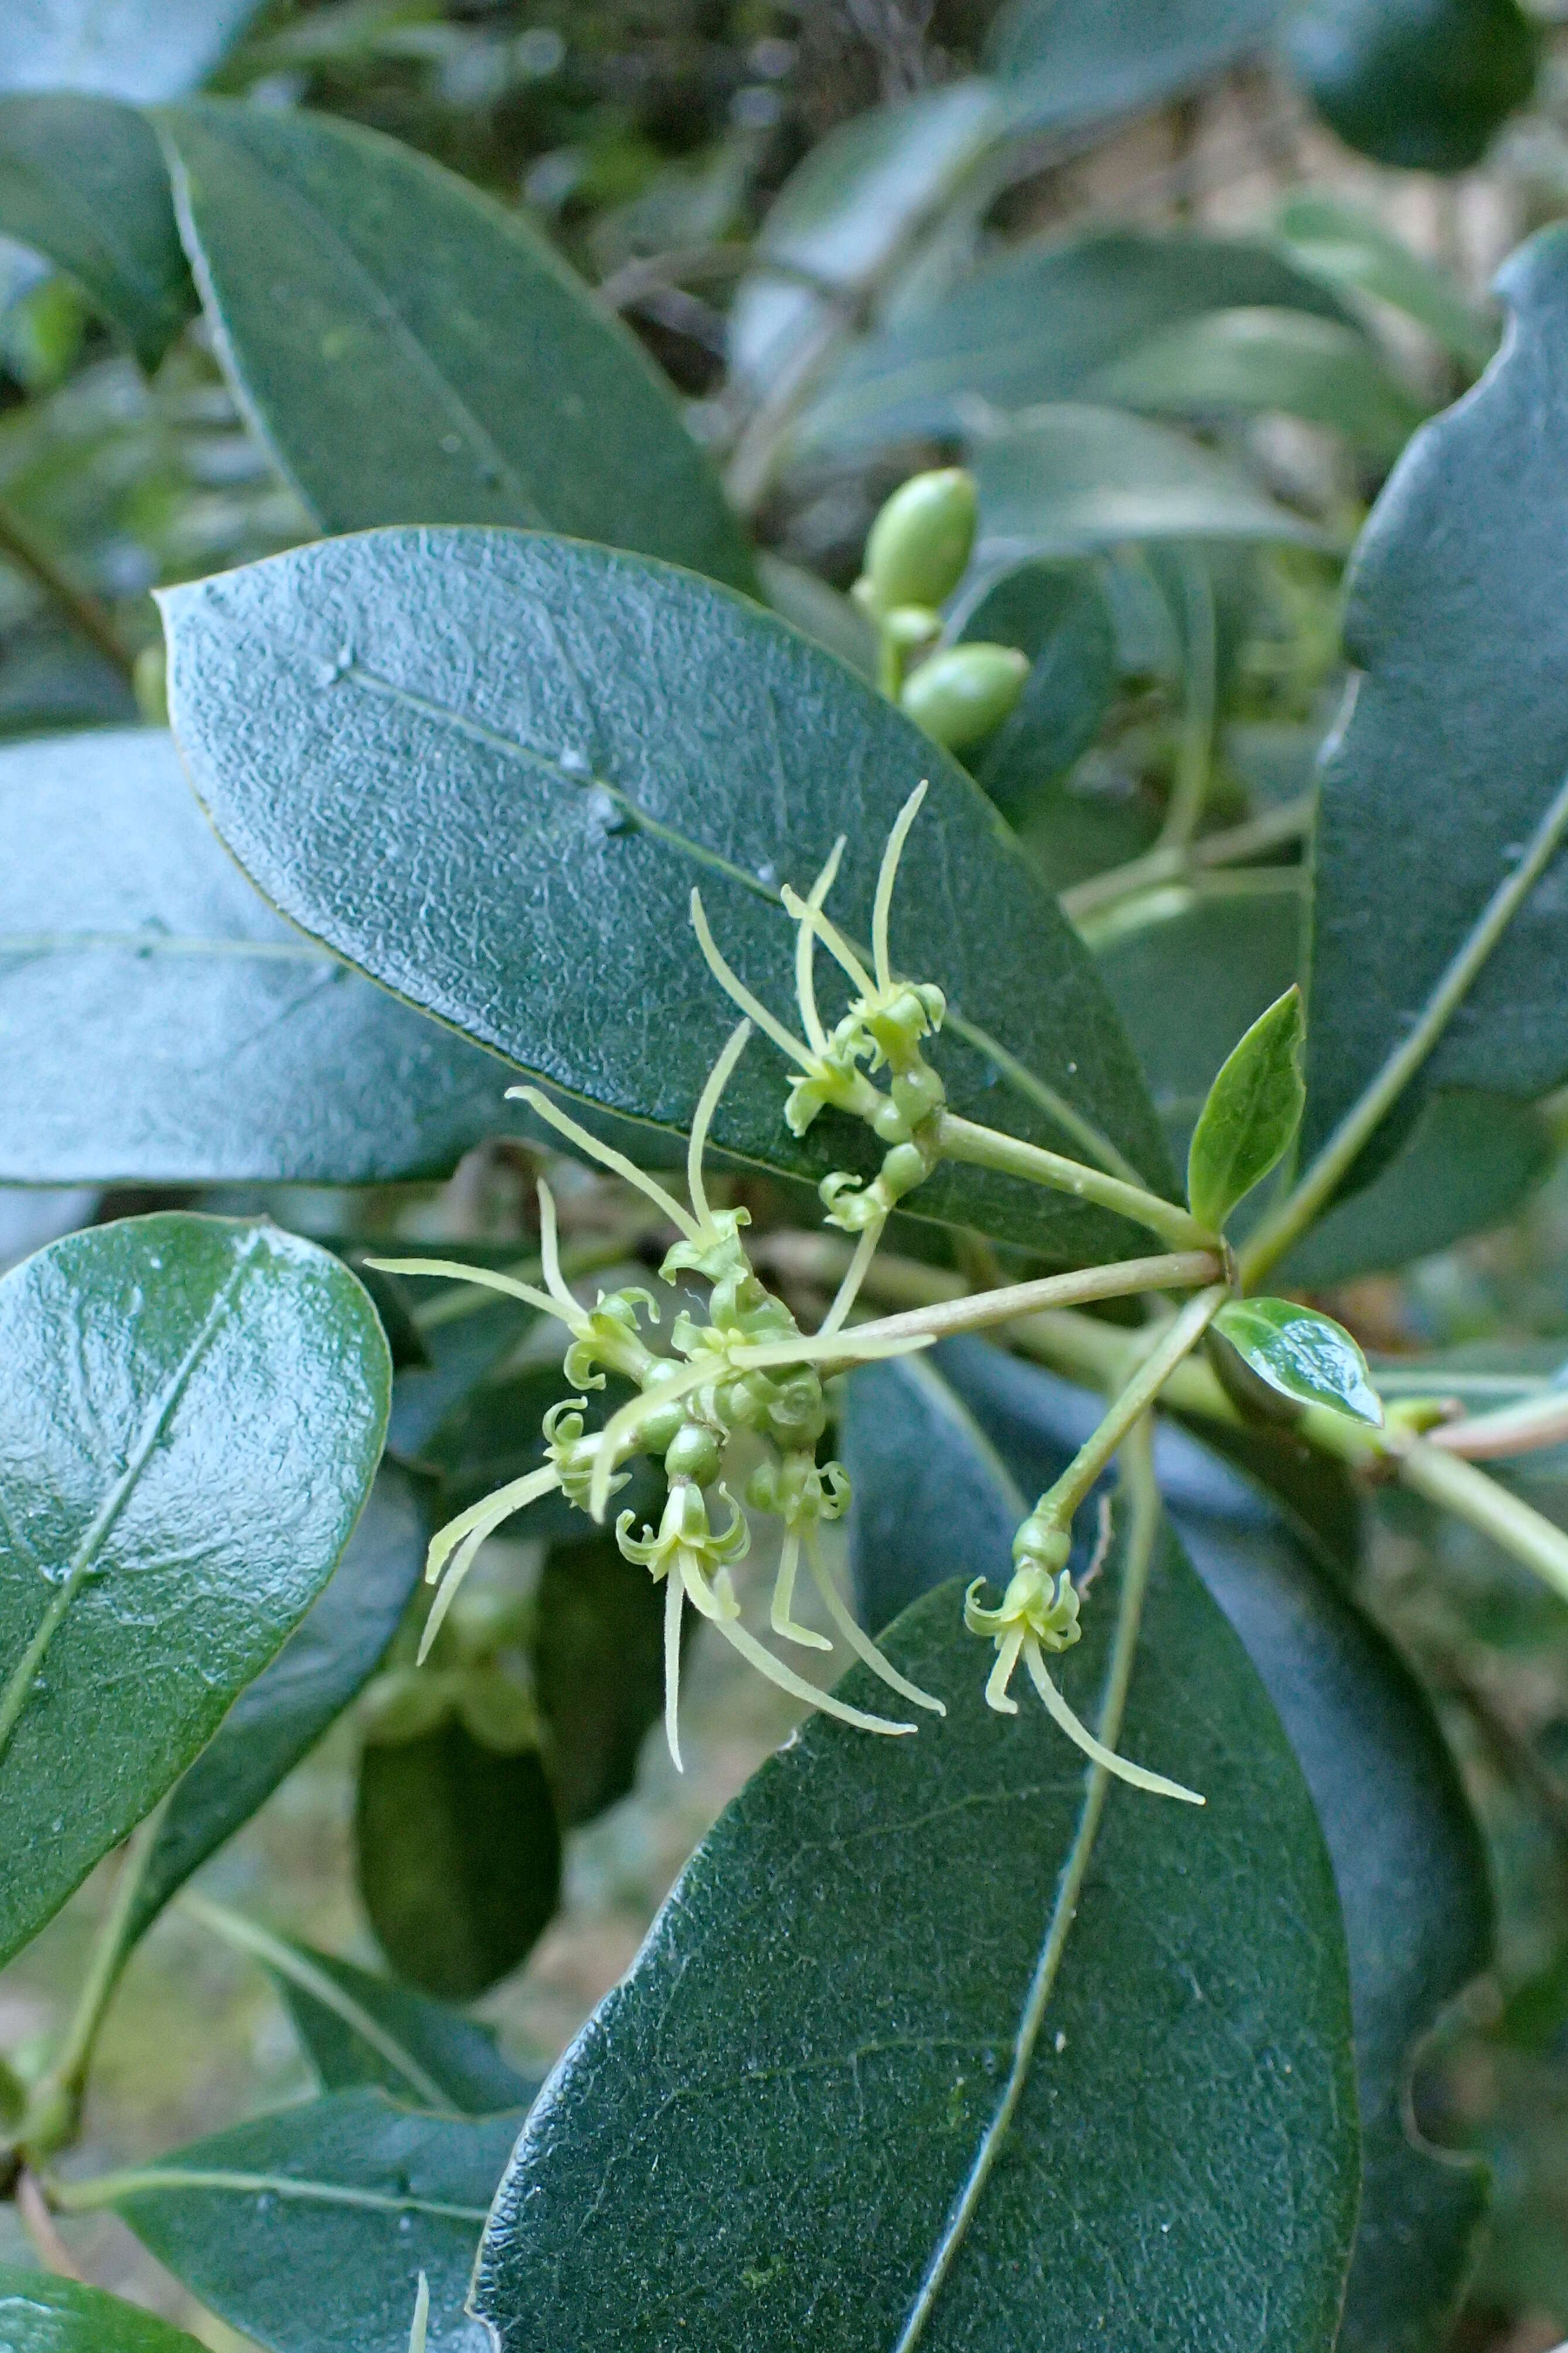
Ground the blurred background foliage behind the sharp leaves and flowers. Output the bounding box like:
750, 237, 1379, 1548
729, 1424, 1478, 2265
0, 0, 1568, 2353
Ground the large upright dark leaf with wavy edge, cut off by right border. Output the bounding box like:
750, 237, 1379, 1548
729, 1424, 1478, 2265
1302, 229, 1568, 1179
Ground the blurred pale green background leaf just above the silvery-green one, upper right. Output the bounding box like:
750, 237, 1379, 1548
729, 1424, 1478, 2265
1086, 308, 1427, 459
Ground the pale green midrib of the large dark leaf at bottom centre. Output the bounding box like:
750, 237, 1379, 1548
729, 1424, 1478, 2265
893, 1424, 1162, 2353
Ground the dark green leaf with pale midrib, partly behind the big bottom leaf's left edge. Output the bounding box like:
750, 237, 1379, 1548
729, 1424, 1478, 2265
106, 2092, 517, 2353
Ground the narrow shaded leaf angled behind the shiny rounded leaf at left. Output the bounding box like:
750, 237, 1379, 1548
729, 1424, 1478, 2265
125, 1464, 430, 1948
